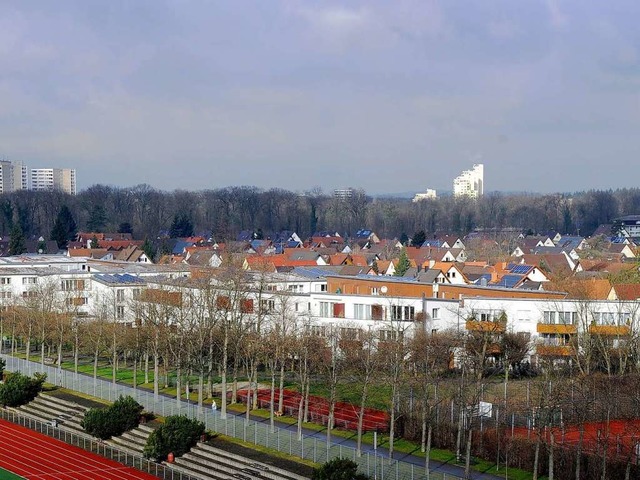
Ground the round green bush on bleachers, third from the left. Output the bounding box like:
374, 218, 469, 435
144, 415, 205, 461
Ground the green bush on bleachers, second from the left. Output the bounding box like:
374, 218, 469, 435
81, 396, 143, 440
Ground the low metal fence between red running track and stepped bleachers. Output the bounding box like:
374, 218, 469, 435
0, 409, 199, 480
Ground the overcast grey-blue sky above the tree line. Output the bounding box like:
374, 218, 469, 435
0, 0, 640, 193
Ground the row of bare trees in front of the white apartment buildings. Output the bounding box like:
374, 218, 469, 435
0, 276, 640, 479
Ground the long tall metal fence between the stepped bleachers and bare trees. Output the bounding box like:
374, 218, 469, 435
0, 355, 462, 480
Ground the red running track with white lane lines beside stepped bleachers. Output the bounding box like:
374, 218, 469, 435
0, 420, 157, 480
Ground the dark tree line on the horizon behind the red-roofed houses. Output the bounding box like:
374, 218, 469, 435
0, 185, 640, 246
